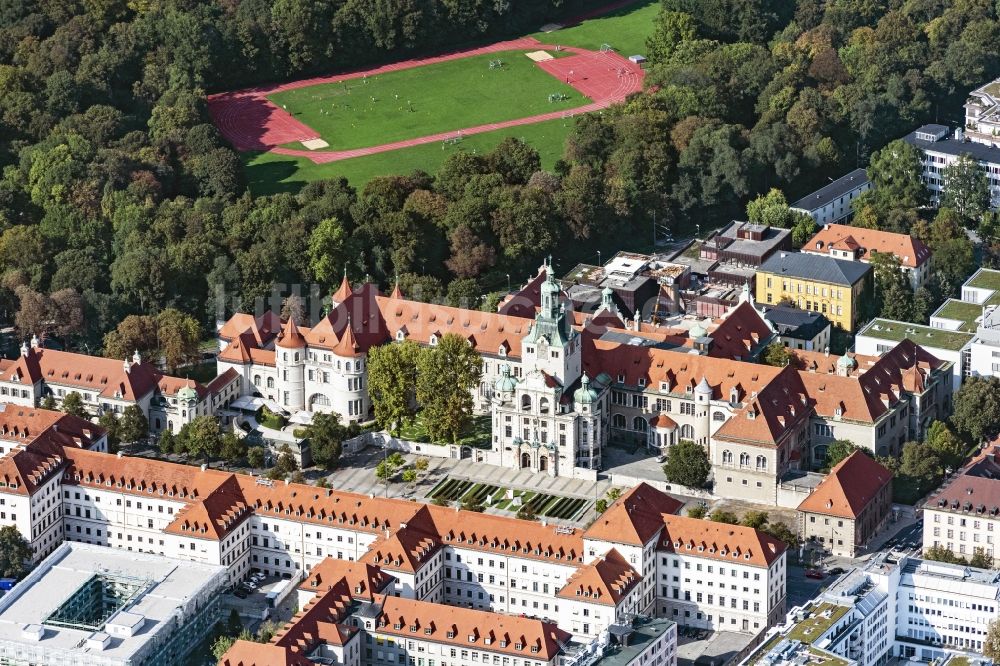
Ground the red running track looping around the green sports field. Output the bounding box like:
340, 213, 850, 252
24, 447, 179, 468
208, 37, 643, 164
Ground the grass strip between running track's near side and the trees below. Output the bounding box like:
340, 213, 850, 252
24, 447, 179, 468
241, 119, 573, 196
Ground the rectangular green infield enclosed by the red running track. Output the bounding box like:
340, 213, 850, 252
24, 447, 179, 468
268, 51, 589, 150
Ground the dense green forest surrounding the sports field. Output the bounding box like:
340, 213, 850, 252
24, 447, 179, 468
0, 0, 1000, 346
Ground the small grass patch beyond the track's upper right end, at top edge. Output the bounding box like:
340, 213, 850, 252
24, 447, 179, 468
532, 0, 660, 58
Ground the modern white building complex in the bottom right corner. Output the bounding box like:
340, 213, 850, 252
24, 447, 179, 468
743, 553, 1000, 666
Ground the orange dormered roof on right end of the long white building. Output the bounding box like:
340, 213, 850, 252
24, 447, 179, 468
659, 515, 787, 567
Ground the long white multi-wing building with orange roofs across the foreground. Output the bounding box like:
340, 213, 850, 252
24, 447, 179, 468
0, 428, 786, 660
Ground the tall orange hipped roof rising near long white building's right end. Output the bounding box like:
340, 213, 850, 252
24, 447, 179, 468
583, 483, 684, 546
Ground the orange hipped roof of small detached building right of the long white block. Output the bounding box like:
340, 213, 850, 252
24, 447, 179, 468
799, 451, 892, 519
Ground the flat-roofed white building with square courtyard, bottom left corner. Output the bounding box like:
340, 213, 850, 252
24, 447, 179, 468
0, 542, 228, 666
